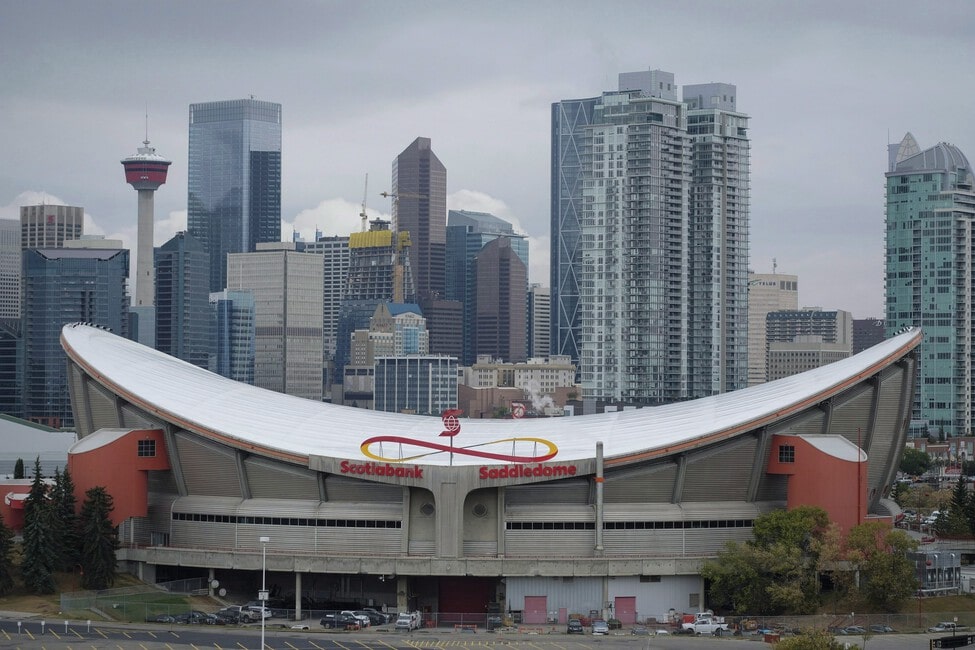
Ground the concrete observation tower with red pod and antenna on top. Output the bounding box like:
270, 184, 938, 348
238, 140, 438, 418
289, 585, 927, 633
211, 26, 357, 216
121, 139, 172, 307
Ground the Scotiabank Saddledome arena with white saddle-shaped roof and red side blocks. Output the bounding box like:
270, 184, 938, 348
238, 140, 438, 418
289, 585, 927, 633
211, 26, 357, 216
61, 324, 921, 624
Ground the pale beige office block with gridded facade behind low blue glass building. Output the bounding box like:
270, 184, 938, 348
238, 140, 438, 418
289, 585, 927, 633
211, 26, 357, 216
227, 242, 324, 401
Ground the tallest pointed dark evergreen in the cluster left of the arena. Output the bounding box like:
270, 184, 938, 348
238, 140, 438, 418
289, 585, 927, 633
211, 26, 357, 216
20, 456, 58, 594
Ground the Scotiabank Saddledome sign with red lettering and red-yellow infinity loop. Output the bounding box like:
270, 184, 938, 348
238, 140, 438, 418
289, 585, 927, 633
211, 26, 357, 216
339, 410, 577, 480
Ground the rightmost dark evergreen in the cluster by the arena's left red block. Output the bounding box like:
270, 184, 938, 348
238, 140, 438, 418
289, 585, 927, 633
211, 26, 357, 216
79, 487, 119, 589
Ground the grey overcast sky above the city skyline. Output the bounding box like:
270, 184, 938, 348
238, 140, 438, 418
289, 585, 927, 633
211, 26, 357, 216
0, 0, 975, 318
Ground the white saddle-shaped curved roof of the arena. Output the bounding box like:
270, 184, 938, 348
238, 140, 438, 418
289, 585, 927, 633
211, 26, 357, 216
61, 324, 921, 465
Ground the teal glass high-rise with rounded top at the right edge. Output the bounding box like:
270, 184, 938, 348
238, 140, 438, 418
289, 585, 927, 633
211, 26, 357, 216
886, 133, 975, 436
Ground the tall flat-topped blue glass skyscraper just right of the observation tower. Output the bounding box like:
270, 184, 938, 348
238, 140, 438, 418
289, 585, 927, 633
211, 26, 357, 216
187, 99, 281, 291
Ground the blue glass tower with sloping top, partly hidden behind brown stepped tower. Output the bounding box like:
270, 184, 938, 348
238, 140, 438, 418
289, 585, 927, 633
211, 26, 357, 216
447, 210, 528, 365
